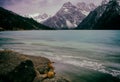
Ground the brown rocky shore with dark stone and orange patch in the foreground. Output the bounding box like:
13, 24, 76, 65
0, 50, 70, 82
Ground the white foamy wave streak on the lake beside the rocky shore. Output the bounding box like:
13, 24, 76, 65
41, 52, 120, 78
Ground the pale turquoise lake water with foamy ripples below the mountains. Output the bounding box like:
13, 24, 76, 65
0, 30, 120, 82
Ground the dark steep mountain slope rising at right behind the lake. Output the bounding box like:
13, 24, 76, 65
77, 0, 120, 30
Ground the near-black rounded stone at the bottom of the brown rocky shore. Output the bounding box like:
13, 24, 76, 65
8, 60, 36, 82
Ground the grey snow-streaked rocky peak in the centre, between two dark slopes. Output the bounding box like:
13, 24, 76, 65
43, 2, 95, 29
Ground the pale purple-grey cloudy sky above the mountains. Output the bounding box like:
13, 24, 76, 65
0, 0, 102, 15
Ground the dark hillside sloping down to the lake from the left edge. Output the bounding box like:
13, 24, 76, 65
0, 7, 51, 30
